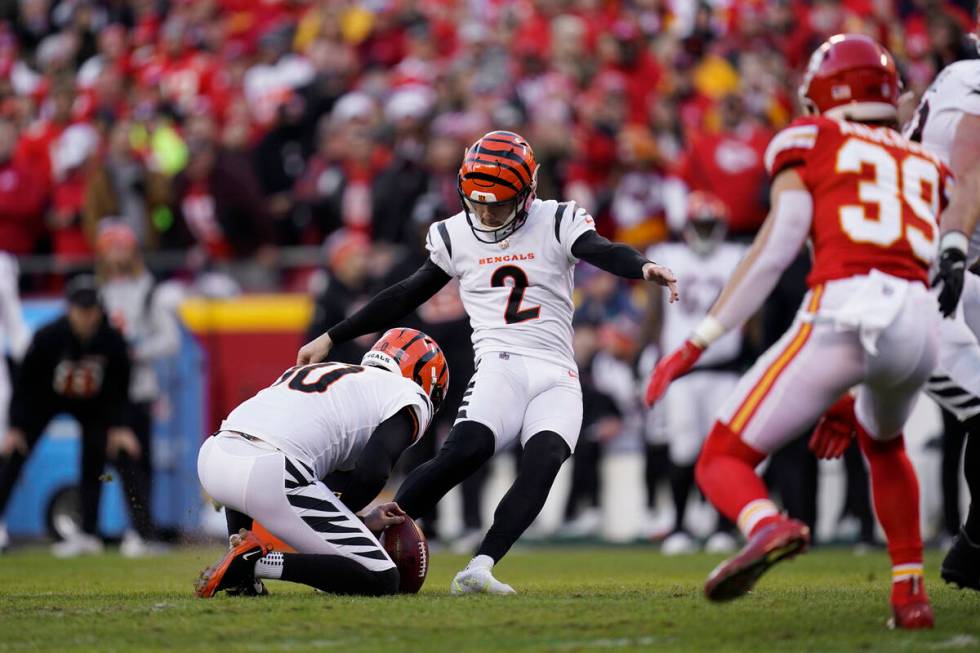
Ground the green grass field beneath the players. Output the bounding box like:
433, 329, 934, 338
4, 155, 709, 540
0, 547, 980, 653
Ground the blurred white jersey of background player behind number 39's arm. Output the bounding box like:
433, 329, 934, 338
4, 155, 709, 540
647, 243, 746, 369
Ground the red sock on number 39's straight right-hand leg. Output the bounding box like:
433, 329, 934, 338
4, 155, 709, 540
858, 428, 922, 569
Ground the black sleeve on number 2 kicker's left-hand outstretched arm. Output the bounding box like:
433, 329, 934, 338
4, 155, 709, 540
327, 259, 452, 343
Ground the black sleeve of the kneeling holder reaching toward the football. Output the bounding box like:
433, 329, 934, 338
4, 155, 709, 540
330, 406, 421, 512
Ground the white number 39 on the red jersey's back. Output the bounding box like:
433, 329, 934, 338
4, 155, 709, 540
837, 138, 939, 263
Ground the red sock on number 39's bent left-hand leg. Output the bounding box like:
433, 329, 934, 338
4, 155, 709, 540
694, 422, 781, 537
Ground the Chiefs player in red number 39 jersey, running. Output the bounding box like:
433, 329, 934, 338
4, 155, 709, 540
647, 34, 948, 628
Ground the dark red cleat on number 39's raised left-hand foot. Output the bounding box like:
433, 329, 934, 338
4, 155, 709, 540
704, 519, 810, 601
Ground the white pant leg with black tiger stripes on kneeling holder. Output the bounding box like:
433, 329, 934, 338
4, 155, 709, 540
246, 453, 395, 571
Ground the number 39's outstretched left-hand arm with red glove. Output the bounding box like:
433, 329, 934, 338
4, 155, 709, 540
646, 169, 813, 405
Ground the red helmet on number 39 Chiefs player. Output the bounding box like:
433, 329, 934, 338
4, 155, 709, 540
799, 34, 902, 120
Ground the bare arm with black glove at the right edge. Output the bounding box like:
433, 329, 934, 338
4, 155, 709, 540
933, 114, 980, 317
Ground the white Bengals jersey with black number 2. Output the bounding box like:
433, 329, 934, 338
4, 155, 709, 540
426, 200, 595, 369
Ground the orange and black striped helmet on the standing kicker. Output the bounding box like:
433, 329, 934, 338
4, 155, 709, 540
457, 131, 538, 243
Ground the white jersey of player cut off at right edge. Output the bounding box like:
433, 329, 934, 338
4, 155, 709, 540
903, 59, 980, 261
